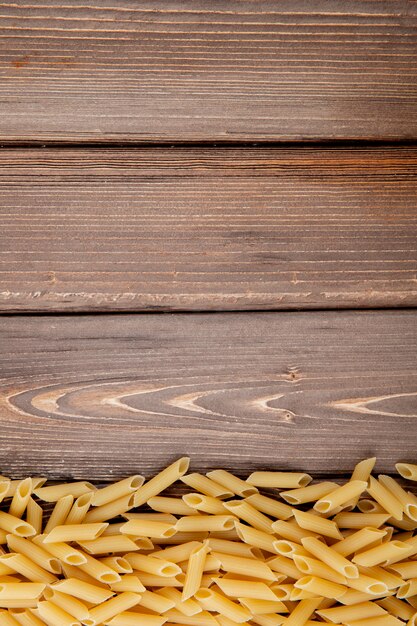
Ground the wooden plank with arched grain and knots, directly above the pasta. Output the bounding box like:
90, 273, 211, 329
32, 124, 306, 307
0, 310, 417, 480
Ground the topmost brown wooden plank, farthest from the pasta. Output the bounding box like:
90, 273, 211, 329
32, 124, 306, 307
0, 0, 417, 142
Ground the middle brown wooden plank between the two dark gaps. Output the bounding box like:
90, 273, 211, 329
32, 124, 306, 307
0, 148, 417, 312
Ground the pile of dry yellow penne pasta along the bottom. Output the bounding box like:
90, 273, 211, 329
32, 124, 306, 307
0, 457, 417, 626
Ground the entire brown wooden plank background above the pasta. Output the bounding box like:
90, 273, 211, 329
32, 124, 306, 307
0, 0, 417, 480
